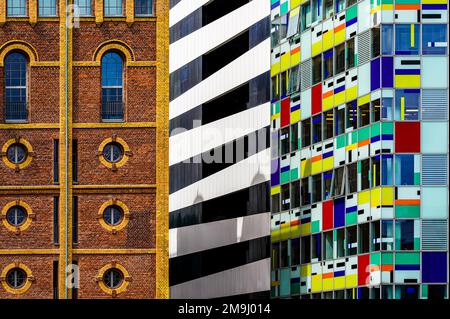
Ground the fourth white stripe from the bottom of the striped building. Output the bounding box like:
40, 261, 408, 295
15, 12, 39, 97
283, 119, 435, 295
169, 103, 270, 165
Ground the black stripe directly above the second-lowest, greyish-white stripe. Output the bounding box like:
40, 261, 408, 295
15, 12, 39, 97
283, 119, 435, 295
169, 182, 270, 229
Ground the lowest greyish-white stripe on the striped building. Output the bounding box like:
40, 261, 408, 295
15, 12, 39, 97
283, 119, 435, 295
170, 258, 270, 299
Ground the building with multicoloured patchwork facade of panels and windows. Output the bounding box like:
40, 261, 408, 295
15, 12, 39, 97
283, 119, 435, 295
271, 0, 448, 299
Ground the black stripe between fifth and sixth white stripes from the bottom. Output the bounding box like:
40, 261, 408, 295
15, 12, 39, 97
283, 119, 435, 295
169, 17, 270, 101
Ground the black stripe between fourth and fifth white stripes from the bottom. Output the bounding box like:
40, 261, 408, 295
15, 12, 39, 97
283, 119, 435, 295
169, 71, 270, 136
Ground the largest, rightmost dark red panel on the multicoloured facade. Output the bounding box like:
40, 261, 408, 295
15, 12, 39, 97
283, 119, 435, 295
394, 122, 420, 153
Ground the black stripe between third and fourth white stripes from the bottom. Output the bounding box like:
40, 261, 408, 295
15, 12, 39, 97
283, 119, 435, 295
169, 126, 270, 194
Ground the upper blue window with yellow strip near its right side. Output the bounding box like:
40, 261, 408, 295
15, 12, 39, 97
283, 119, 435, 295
395, 24, 420, 55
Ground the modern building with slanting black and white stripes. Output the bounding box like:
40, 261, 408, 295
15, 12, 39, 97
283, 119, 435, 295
169, 0, 270, 298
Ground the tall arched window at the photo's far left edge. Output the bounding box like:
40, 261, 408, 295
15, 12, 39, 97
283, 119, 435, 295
5, 52, 28, 121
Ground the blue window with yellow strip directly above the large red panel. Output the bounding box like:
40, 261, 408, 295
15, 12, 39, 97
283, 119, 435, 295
395, 89, 420, 121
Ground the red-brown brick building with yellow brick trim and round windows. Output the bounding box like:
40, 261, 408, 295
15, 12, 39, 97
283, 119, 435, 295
0, 0, 168, 298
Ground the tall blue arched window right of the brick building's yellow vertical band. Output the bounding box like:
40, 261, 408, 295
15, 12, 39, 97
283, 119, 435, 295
102, 52, 123, 121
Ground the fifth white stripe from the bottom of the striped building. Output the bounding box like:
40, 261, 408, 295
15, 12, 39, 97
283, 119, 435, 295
169, 39, 270, 119
